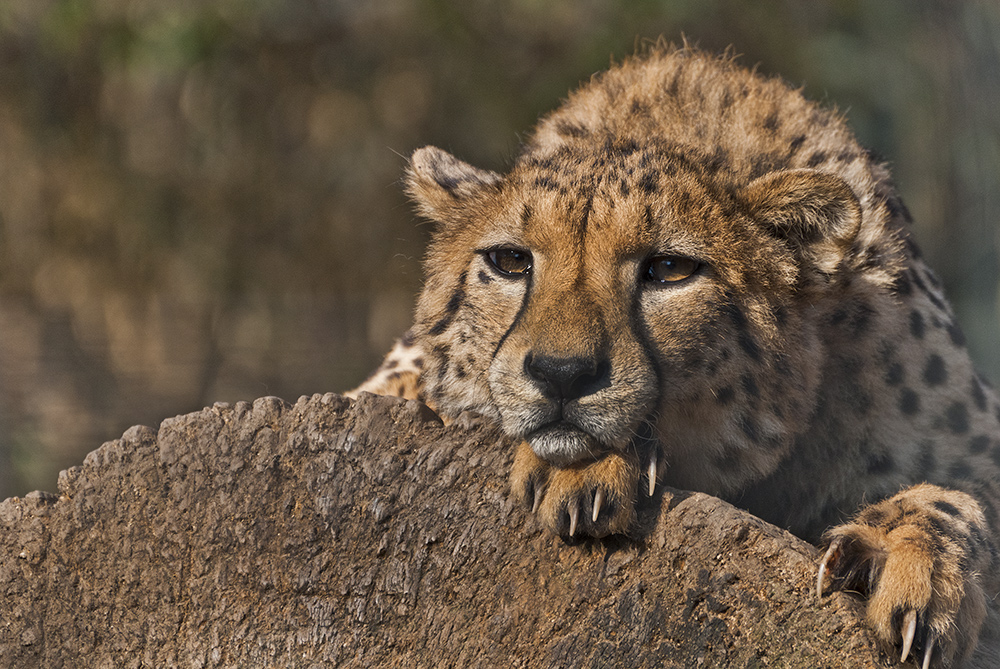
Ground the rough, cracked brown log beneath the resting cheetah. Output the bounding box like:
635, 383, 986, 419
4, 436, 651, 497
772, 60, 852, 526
0, 395, 894, 668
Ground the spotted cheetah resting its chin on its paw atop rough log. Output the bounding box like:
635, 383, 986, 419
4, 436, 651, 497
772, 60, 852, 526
355, 42, 1000, 667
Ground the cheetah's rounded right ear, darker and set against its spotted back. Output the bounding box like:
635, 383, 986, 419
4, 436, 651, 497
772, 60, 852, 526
743, 169, 861, 274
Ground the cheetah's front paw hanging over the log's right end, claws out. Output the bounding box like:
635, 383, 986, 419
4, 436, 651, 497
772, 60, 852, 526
816, 484, 989, 669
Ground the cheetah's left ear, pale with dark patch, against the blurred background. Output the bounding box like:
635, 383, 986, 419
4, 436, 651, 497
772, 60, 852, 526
406, 146, 501, 222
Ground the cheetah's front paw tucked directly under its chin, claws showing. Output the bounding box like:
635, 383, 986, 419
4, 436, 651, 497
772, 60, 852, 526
511, 442, 656, 537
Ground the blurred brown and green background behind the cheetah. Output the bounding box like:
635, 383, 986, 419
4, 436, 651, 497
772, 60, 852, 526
0, 0, 1000, 499
